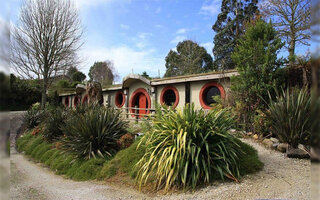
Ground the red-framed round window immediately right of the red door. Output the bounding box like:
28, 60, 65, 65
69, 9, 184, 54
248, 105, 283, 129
160, 86, 179, 108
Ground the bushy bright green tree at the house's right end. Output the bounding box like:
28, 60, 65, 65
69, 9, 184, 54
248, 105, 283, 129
231, 19, 284, 131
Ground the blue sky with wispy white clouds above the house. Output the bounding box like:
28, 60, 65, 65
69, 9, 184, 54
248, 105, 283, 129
0, 0, 314, 80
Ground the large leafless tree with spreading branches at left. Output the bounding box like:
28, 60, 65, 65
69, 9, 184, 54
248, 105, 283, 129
11, 0, 82, 108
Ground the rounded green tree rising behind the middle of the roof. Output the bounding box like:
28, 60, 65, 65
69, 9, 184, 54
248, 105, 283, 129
164, 40, 213, 77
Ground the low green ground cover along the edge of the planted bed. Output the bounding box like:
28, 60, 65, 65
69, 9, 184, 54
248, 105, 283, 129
17, 132, 263, 188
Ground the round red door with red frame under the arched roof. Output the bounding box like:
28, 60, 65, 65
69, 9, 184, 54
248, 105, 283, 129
129, 88, 151, 118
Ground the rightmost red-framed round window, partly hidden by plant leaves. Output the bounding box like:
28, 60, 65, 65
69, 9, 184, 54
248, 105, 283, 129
199, 82, 225, 109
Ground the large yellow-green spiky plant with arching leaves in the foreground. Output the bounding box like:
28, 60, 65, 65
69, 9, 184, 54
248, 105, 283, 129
136, 104, 241, 190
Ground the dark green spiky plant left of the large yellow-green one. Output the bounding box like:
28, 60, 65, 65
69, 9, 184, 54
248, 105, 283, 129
62, 105, 127, 159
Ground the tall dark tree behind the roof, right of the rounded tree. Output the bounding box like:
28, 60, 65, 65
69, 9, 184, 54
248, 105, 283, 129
212, 0, 258, 70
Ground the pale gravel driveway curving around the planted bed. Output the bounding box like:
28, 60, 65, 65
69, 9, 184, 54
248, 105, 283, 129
10, 112, 311, 200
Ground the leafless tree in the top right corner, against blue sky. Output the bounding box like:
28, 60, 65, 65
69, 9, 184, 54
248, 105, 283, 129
260, 0, 311, 63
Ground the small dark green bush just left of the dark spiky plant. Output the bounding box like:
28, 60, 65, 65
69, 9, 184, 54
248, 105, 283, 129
42, 107, 68, 141
